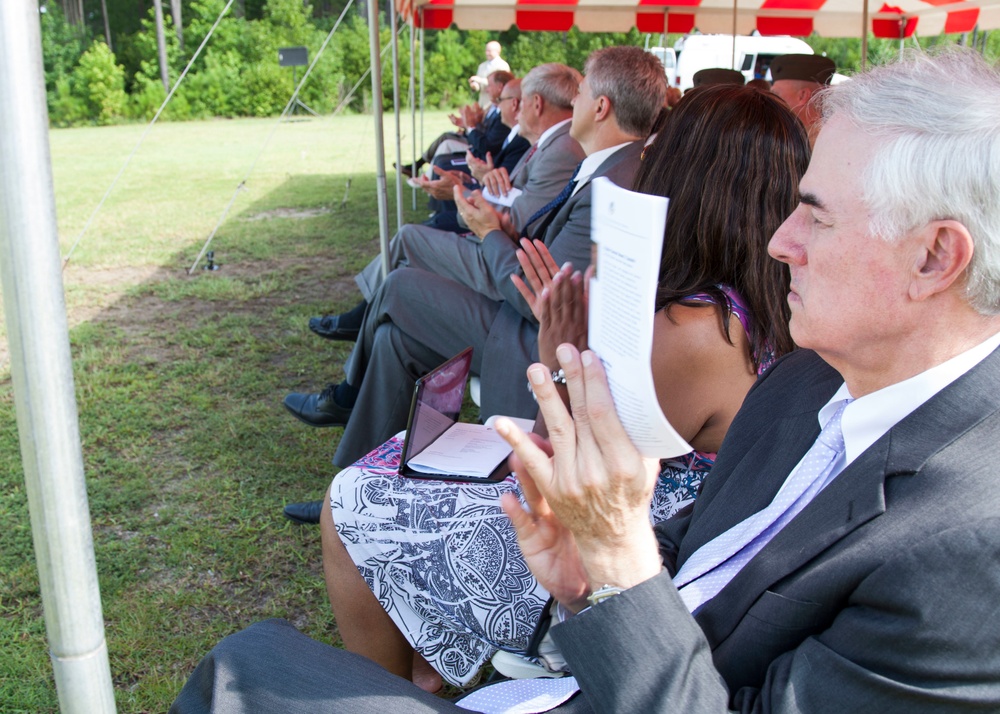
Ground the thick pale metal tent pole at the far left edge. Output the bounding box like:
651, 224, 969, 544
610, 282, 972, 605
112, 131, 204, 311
0, 2, 115, 714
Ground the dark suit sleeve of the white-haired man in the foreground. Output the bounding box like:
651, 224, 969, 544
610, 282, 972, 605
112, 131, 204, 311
552, 518, 1000, 714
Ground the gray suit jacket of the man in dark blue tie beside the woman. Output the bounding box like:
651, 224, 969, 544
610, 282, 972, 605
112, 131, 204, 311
481, 141, 643, 418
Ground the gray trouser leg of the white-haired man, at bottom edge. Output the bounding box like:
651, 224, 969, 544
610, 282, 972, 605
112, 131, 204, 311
170, 620, 593, 714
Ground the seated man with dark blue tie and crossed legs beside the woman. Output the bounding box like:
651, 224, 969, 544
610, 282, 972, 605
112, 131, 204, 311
285, 47, 666, 466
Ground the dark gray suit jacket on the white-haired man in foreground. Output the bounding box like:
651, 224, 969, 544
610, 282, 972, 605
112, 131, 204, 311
552, 344, 1000, 714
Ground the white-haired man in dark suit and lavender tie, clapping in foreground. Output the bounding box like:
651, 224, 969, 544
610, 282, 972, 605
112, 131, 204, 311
175, 52, 1000, 714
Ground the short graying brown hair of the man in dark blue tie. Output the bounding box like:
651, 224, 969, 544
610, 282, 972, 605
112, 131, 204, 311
584, 47, 667, 137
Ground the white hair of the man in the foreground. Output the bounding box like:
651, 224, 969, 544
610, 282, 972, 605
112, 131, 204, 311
819, 49, 1000, 315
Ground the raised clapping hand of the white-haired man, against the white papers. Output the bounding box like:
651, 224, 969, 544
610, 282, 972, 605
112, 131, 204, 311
496, 344, 662, 610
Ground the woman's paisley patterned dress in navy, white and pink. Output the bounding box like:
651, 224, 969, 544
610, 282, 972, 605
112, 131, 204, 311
330, 290, 764, 686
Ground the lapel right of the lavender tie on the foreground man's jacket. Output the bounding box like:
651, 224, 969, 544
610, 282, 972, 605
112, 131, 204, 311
685, 344, 1000, 643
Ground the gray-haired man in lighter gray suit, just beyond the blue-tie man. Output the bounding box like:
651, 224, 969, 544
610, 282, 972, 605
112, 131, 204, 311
309, 63, 584, 340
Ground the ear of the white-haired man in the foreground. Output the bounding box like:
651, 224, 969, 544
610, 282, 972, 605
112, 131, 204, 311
909, 220, 975, 301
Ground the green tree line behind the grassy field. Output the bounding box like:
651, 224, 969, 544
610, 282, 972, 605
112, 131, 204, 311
39, 0, 1000, 126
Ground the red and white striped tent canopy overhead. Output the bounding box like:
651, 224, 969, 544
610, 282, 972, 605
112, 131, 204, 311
396, 0, 1000, 38
